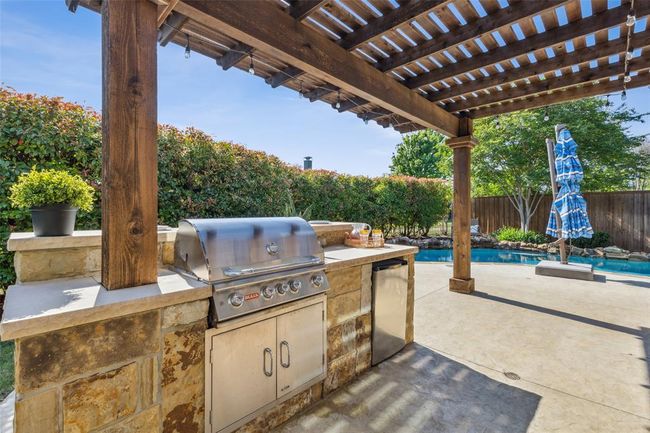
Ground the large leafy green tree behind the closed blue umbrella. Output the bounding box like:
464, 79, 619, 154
472, 98, 642, 231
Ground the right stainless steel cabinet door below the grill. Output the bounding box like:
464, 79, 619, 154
276, 303, 325, 398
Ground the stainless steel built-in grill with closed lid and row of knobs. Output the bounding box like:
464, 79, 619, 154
174, 218, 329, 322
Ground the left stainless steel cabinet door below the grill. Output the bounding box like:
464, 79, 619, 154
211, 318, 277, 432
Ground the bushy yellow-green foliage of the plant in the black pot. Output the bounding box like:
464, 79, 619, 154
9, 169, 93, 212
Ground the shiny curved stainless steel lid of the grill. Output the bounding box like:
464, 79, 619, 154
174, 217, 324, 283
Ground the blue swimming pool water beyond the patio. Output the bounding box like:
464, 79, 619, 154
415, 248, 650, 277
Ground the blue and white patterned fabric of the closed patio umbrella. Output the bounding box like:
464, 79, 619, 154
546, 128, 594, 239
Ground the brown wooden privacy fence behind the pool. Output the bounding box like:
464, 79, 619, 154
472, 191, 650, 251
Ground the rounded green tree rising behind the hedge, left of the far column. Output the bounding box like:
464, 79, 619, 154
390, 129, 451, 179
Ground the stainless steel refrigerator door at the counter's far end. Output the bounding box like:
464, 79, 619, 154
372, 263, 408, 365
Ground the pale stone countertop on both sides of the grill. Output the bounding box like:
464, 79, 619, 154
0, 245, 418, 340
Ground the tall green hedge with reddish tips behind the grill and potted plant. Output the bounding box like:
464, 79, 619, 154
0, 88, 450, 288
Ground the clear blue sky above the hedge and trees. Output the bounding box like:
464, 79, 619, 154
0, 0, 650, 176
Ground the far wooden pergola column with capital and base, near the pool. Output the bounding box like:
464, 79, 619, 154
447, 118, 476, 293
